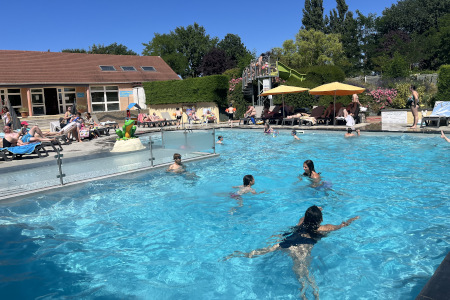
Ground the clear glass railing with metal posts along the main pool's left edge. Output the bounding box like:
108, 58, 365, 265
0, 129, 217, 199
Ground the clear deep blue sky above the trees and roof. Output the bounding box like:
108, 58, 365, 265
0, 0, 397, 55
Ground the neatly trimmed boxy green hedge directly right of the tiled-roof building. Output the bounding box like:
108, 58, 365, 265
143, 75, 228, 106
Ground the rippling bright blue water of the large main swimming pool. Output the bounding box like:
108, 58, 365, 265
0, 130, 450, 299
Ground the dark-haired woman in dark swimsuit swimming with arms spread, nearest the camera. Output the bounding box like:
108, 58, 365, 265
225, 205, 359, 298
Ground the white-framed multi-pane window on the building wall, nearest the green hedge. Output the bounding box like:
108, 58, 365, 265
91, 86, 120, 112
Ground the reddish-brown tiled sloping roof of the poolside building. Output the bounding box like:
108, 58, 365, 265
0, 50, 180, 86
